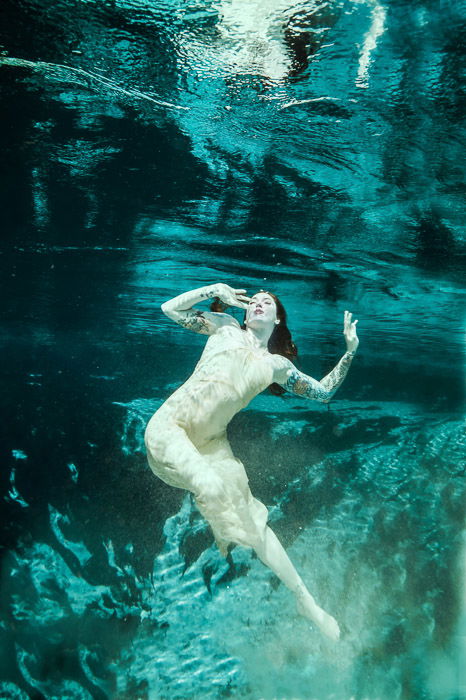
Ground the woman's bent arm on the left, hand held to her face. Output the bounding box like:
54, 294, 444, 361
161, 283, 248, 335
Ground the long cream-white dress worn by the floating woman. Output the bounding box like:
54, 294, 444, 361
146, 322, 276, 553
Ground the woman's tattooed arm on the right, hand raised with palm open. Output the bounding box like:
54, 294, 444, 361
274, 311, 359, 403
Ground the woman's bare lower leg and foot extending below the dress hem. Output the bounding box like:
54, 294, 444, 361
255, 527, 340, 640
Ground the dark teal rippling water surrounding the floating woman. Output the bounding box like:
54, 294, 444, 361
0, 0, 466, 700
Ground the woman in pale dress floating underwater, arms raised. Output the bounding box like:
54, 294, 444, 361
145, 284, 359, 639
